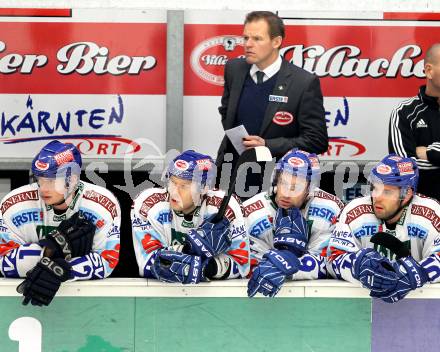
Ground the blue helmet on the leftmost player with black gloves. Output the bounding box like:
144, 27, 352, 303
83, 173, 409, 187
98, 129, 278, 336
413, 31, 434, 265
32, 140, 82, 183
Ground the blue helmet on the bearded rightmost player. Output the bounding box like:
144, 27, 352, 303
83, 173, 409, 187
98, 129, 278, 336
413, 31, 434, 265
368, 154, 419, 198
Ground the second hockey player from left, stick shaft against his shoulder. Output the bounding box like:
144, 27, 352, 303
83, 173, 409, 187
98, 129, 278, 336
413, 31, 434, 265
131, 150, 249, 284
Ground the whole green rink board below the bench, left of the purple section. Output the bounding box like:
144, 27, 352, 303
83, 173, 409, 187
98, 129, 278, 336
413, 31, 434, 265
0, 297, 371, 352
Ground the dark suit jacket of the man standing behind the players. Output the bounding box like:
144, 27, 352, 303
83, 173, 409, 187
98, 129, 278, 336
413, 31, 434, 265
217, 59, 328, 166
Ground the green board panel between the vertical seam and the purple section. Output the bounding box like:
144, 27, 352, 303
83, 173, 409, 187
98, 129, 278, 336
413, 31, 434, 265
136, 298, 371, 352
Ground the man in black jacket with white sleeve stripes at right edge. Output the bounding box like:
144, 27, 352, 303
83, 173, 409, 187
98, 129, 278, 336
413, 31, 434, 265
388, 43, 440, 200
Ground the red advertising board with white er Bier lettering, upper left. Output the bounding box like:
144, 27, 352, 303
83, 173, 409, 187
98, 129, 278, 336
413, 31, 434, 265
0, 22, 166, 94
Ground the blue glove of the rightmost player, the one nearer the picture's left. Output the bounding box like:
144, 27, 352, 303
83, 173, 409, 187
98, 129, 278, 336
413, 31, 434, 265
352, 248, 399, 295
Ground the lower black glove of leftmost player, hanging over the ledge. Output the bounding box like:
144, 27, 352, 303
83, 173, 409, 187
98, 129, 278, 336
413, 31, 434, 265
17, 257, 71, 306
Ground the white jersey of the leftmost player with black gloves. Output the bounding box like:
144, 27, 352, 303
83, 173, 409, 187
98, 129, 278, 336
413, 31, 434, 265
0, 182, 121, 280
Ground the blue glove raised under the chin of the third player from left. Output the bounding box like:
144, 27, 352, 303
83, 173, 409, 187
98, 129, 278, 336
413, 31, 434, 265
273, 208, 308, 257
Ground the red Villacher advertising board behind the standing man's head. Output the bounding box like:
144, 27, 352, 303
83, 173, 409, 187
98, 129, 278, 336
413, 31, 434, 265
185, 24, 432, 97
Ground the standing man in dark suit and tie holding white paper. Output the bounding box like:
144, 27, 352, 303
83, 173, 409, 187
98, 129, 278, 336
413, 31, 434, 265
217, 11, 328, 196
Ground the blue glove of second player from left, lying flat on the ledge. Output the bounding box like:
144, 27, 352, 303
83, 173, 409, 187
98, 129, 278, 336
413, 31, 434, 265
151, 249, 205, 284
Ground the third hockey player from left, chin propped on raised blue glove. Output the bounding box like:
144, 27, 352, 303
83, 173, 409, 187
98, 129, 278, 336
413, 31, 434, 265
243, 149, 343, 297
